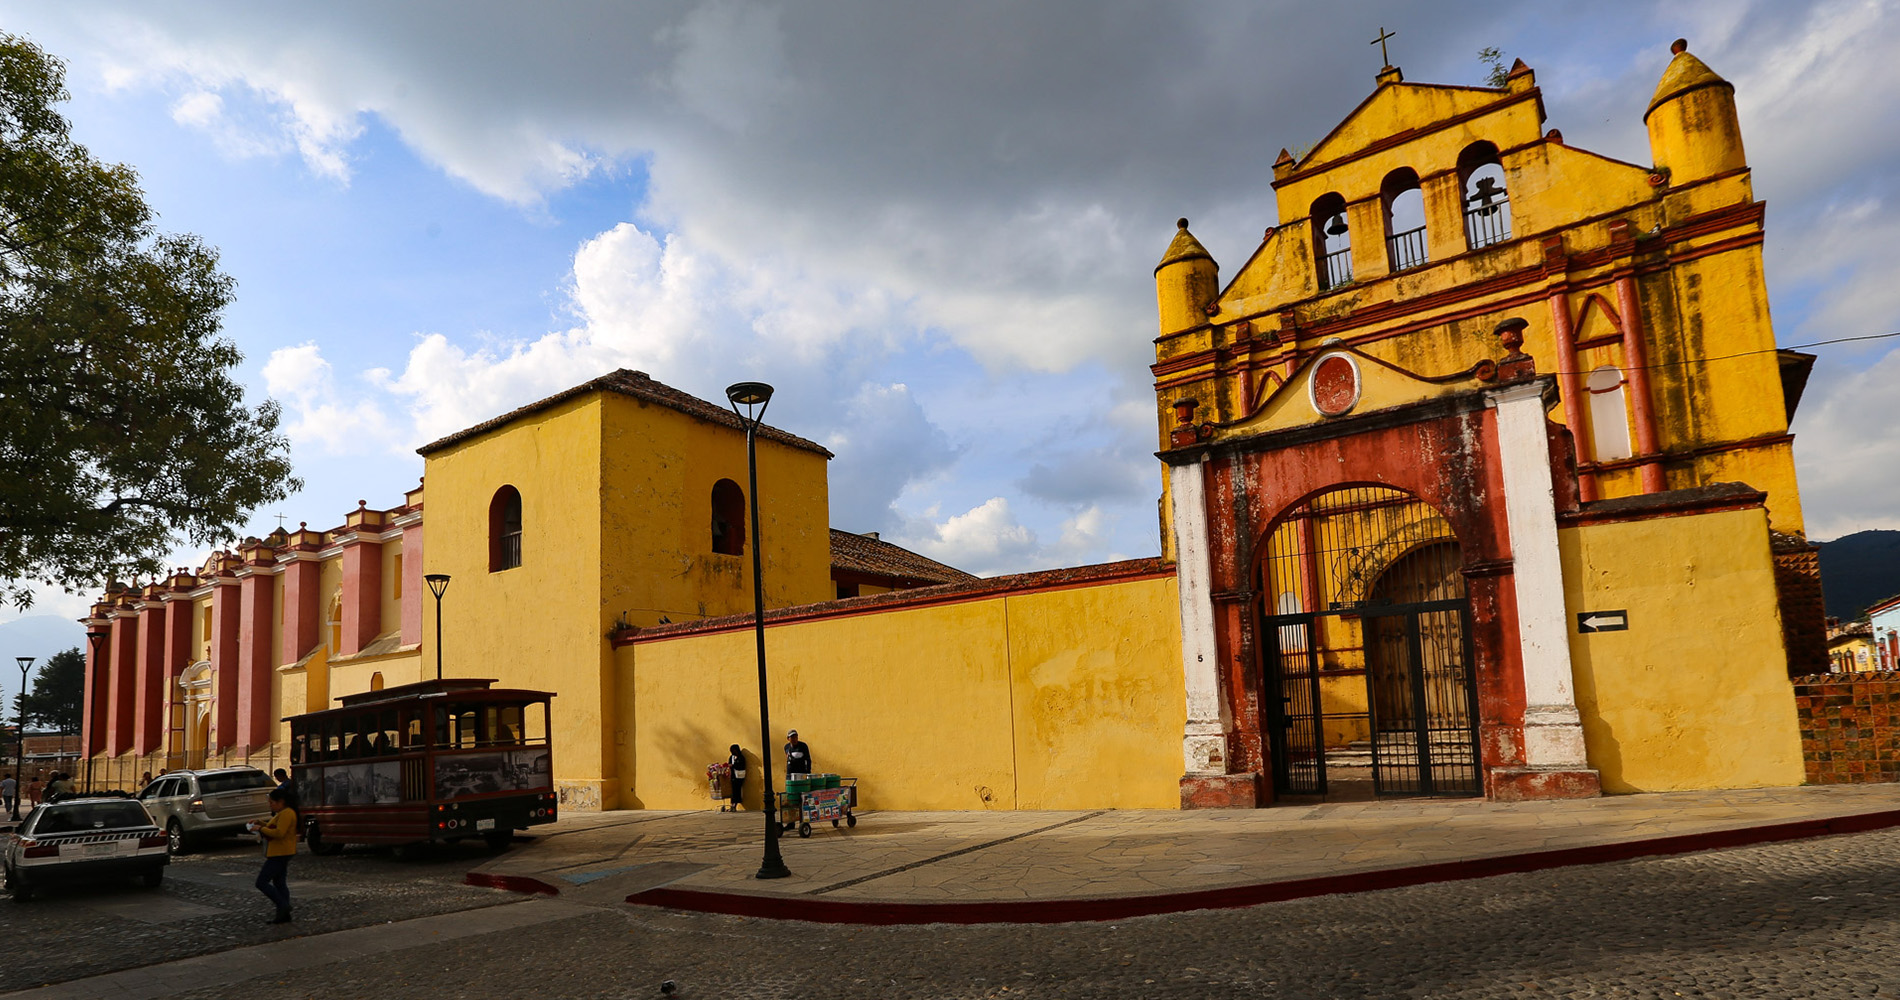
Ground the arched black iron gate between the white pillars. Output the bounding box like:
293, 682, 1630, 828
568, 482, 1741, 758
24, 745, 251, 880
1260, 487, 1482, 795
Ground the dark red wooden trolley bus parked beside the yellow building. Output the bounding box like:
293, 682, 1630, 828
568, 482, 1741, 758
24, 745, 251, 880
285, 679, 555, 854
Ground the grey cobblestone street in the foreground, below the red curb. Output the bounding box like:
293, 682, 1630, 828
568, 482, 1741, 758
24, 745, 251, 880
4, 831, 1900, 1000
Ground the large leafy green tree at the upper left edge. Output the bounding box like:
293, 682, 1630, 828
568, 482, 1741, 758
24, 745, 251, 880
0, 32, 302, 606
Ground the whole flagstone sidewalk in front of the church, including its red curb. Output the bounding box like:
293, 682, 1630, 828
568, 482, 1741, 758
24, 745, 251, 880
469, 785, 1900, 924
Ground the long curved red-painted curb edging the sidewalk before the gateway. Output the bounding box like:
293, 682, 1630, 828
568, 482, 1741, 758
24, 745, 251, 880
619, 810, 1900, 924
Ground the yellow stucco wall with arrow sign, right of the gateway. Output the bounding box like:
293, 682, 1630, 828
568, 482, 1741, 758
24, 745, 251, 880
1558, 510, 1803, 793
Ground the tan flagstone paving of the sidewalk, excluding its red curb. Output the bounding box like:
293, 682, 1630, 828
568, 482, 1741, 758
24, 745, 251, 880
477, 785, 1900, 903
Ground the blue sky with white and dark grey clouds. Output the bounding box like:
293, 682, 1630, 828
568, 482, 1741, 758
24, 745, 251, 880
0, 0, 1900, 634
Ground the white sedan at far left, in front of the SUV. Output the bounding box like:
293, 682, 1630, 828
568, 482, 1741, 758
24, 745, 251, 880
0, 798, 169, 903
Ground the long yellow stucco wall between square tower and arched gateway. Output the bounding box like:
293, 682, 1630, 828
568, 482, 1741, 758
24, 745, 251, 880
618, 578, 1186, 810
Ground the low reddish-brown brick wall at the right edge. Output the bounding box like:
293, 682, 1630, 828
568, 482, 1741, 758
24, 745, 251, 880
1794, 671, 1900, 785
